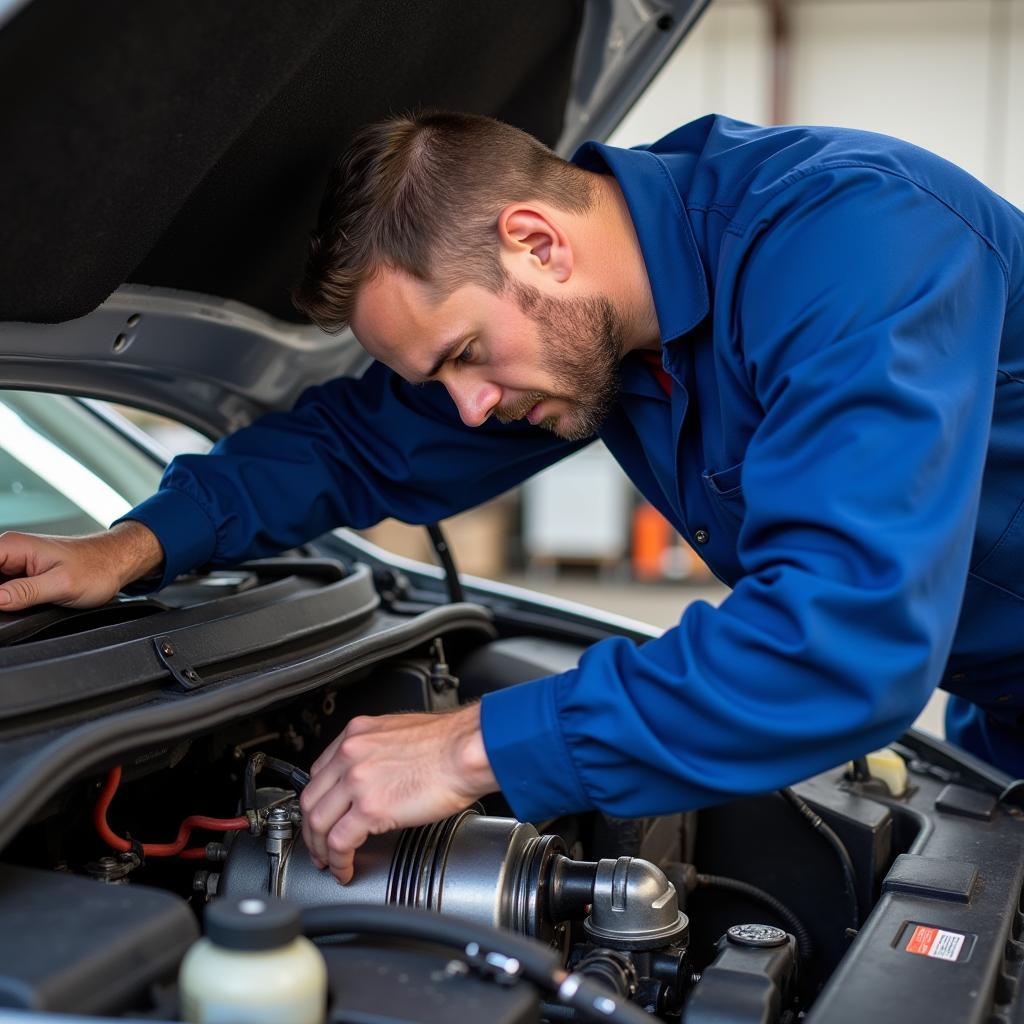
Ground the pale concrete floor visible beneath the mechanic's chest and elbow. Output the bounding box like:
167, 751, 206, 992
506, 572, 946, 736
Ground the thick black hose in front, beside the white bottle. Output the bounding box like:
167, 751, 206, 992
302, 903, 650, 1024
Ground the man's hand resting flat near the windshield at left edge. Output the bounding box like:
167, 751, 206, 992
0, 520, 164, 611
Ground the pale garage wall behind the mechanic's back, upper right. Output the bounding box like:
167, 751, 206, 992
612, 0, 1024, 206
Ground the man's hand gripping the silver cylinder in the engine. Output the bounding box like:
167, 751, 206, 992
301, 705, 498, 884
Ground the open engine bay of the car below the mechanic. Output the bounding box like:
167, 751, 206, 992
0, 559, 1024, 1024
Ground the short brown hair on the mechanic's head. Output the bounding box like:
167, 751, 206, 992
293, 111, 593, 333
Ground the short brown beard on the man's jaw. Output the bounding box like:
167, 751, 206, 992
495, 281, 625, 441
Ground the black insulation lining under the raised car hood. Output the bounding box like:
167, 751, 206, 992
0, 0, 583, 323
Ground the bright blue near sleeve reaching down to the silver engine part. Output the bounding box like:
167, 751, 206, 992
482, 168, 1007, 820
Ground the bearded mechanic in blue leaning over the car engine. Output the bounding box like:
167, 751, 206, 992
0, 114, 1024, 881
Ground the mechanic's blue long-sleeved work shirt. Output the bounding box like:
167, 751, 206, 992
129, 116, 1024, 819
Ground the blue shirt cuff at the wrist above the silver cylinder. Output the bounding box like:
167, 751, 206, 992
480, 676, 593, 821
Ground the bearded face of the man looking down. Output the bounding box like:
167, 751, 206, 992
352, 269, 624, 440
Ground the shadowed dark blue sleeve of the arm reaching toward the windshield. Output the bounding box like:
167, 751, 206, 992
124, 362, 582, 586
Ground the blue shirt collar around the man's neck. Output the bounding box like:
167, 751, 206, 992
572, 142, 711, 343
